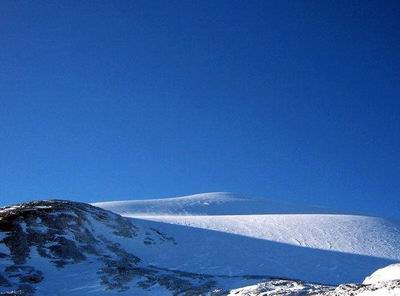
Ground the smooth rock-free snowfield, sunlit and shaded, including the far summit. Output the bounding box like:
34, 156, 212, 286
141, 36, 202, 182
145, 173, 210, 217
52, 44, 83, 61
95, 193, 400, 284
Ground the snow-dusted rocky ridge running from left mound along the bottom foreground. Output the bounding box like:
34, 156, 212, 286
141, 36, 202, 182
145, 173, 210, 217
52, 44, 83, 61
0, 200, 399, 296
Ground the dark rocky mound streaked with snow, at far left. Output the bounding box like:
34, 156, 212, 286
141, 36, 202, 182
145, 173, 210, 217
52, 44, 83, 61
0, 200, 179, 295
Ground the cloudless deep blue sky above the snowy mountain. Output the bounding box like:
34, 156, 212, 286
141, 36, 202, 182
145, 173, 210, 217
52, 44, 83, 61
0, 0, 400, 218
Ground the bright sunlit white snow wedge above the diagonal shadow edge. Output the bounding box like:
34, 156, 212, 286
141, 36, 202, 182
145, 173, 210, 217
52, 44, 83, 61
137, 214, 400, 260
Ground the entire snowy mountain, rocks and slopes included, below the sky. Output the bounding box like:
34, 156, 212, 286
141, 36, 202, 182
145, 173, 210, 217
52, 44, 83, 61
0, 193, 400, 296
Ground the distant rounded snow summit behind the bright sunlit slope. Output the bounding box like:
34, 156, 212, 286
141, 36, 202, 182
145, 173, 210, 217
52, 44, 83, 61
93, 192, 336, 216
